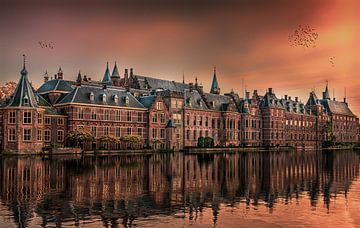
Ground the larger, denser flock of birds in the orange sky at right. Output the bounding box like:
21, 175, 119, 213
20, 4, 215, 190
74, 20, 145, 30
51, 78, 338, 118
288, 25, 319, 48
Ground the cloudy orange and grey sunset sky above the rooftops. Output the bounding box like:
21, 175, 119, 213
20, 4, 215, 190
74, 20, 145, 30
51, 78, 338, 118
0, 0, 360, 115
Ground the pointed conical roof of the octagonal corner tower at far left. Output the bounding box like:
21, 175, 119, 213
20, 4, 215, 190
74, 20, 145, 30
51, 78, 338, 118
8, 62, 38, 108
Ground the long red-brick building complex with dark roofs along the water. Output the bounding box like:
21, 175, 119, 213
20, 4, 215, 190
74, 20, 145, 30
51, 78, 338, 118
0, 58, 359, 153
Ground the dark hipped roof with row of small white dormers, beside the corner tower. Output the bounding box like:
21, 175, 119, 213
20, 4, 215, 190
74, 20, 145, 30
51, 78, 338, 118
56, 85, 144, 108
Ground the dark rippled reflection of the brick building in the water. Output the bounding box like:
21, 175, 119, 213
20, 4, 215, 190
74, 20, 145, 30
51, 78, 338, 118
0, 151, 359, 227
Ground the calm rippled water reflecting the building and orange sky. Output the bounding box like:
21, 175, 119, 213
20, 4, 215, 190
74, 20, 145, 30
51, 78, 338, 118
0, 151, 360, 228
